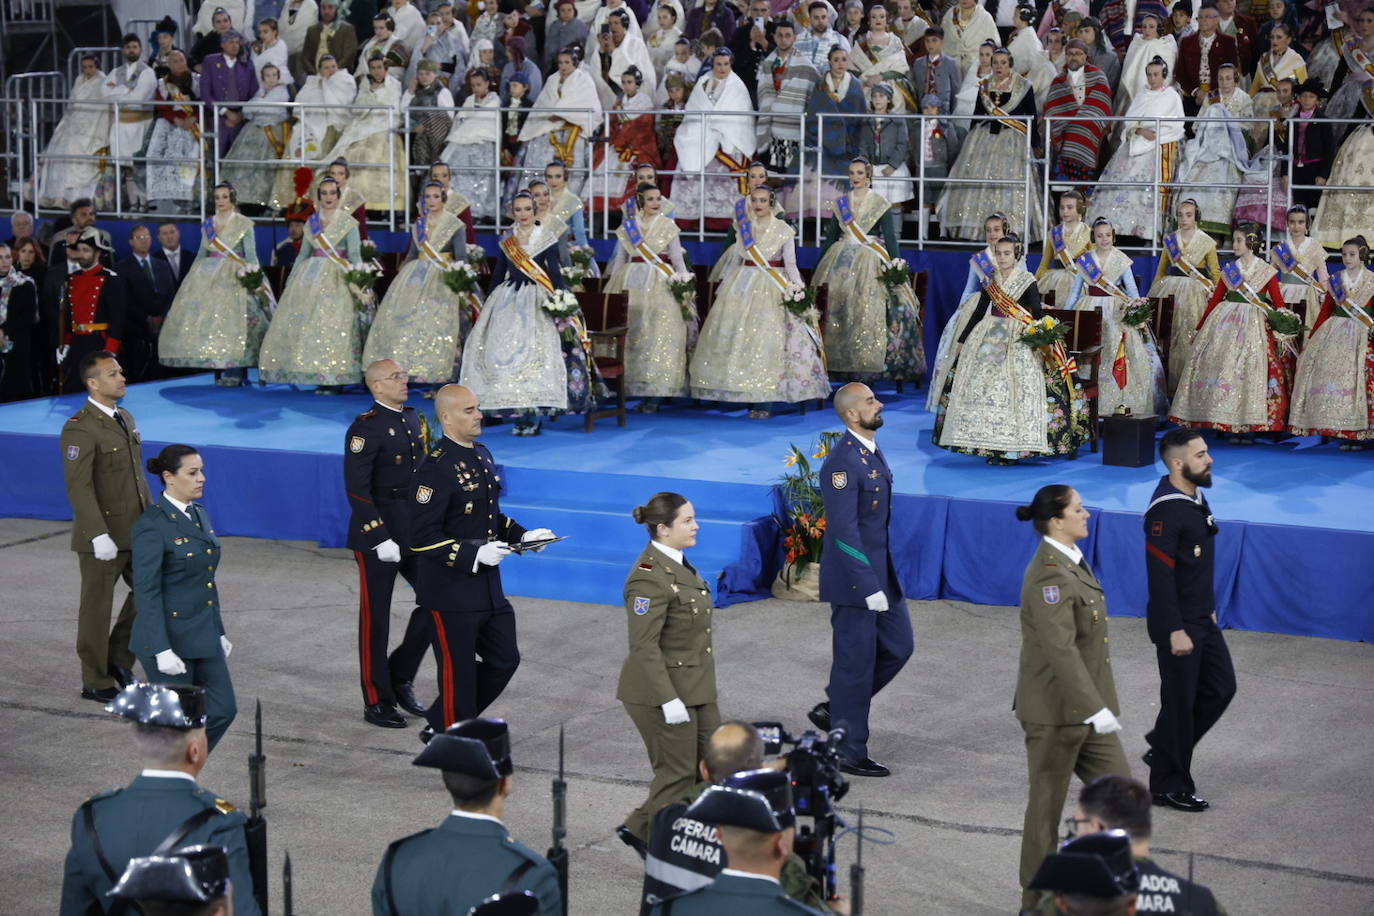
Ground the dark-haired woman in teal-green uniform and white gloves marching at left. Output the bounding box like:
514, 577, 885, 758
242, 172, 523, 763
131, 445, 238, 751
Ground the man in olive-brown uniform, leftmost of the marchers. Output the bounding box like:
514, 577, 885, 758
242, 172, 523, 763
60, 350, 153, 703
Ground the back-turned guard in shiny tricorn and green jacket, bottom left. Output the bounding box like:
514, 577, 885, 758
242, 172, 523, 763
59, 684, 258, 916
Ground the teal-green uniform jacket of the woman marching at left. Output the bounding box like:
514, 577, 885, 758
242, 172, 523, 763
129, 494, 224, 658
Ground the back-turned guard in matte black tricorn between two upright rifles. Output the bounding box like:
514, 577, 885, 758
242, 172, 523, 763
372, 718, 562, 916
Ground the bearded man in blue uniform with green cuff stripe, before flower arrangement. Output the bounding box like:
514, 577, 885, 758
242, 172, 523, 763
808, 382, 912, 776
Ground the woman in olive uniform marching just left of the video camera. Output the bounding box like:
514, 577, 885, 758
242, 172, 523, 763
616, 493, 720, 856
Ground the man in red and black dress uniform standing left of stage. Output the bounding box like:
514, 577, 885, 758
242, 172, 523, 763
58, 225, 125, 394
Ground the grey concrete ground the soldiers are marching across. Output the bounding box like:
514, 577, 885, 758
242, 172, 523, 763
0, 519, 1374, 916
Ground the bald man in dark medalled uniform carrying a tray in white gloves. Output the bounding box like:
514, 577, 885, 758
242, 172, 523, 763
409, 385, 554, 739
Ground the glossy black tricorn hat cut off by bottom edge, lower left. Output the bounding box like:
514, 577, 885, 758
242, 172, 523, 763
109, 846, 234, 916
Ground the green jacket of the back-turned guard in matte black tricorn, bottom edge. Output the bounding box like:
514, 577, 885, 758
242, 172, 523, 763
372, 814, 562, 916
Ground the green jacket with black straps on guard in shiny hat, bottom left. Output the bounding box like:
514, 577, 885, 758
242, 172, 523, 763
59, 776, 258, 916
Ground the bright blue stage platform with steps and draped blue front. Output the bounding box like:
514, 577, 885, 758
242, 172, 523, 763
0, 376, 1374, 641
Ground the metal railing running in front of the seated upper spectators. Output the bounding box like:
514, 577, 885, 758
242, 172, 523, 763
0, 92, 1357, 254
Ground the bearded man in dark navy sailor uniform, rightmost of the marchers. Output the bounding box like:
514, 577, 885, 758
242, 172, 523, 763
1145, 428, 1235, 812
